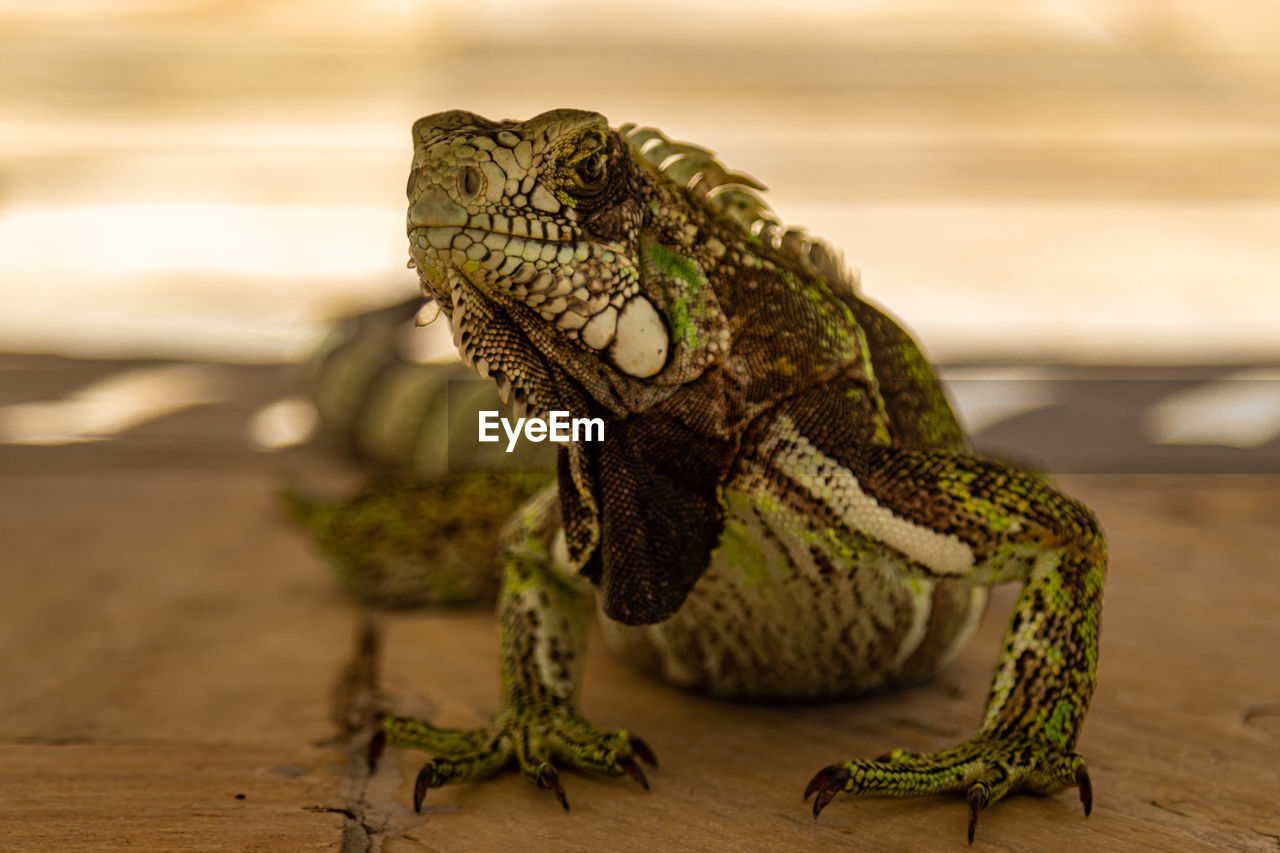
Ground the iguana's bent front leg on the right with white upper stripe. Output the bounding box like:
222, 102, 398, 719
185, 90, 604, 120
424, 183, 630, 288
805, 447, 1107, 843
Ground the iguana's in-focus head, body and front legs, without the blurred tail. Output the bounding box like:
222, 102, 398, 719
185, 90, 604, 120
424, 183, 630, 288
296, 109, 1107, 841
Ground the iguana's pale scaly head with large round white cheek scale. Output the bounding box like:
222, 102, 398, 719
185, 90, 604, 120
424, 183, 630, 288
407, 110, 687, 414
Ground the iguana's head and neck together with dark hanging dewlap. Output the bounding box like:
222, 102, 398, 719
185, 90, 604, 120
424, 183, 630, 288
407, 110, 863, 624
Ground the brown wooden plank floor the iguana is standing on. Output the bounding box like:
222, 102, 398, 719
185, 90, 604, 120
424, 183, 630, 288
0, 350, 1280, 852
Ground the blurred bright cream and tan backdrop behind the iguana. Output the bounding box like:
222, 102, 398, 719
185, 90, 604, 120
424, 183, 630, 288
0, 0, 1280, 461
